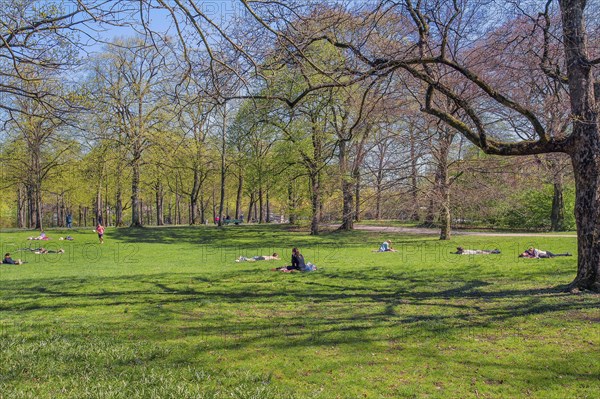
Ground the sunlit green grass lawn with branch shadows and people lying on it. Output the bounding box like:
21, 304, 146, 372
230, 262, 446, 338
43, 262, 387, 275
0, 226, 600, 399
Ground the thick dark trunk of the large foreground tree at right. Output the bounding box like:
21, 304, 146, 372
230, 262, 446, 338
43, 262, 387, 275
559, 0, 600, 292
